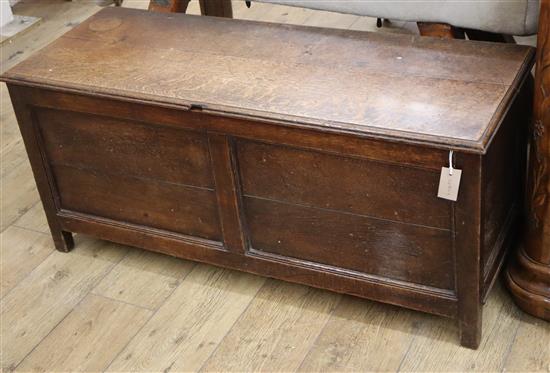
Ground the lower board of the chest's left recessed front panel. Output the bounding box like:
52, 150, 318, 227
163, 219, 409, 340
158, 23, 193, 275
52, 166, 221, 241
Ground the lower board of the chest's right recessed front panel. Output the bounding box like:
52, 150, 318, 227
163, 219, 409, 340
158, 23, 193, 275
248, 197, 454, 289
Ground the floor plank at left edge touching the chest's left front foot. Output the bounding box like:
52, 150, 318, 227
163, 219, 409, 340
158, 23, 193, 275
0, 227, 55, 298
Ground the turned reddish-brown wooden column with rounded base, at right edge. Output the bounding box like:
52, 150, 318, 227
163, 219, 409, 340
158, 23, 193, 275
506, 0, 550, 320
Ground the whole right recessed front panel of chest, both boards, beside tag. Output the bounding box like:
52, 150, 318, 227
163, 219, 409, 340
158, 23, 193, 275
236, 140, 454, 290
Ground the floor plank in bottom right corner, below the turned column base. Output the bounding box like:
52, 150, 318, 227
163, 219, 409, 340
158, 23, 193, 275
504, 313, 550, 372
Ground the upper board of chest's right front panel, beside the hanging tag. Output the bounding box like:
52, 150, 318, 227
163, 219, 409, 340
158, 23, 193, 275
237, 140, 451, 229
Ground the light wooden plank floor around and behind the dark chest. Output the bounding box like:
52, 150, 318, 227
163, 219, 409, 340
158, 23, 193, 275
0, 0, 550, 372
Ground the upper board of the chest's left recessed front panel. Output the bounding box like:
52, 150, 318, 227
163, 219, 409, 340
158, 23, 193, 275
36, 109, 213, 187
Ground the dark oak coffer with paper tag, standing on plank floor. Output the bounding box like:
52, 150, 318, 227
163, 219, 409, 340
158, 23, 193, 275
2, 8, 534, 348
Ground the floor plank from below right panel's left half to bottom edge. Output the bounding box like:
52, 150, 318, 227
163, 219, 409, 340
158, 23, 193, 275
201, 280, 340, 372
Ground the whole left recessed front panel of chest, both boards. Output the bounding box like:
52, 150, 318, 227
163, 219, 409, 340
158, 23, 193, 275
34, 108, 222, 241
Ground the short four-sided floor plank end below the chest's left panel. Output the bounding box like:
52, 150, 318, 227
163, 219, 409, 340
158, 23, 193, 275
93, 249, 195, 309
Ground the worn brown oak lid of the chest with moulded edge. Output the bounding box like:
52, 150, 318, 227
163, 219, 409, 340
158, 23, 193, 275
2, 8, 534, 153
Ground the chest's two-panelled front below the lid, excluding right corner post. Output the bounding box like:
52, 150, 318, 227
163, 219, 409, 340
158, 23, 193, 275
9, 86, 466, 317
